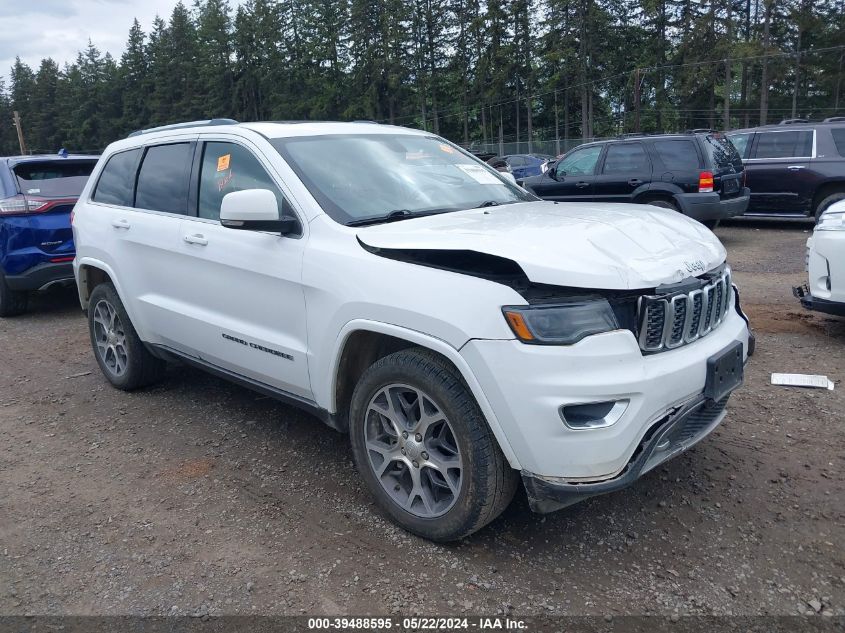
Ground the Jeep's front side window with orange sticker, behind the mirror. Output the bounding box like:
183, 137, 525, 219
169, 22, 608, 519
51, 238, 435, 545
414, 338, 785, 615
198, 142, 291, 220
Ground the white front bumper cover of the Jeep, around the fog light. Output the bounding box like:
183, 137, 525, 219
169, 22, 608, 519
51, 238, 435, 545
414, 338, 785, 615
461, 310, 753, 484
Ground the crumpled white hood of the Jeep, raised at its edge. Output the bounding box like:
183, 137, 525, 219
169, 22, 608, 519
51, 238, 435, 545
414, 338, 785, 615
357, 202, 725, 289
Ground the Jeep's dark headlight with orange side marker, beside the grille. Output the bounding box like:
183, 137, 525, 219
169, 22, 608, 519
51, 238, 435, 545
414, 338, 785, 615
502, 299, 619, 345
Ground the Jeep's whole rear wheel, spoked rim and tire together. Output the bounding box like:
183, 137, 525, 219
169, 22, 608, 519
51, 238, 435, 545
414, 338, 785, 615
88, 283, 165, 391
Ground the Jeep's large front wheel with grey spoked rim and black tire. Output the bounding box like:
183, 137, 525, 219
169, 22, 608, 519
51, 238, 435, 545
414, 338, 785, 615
349, 348, 518, 541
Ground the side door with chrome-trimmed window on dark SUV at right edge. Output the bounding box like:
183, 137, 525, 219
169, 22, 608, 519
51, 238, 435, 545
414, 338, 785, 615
745, 129, 815, 215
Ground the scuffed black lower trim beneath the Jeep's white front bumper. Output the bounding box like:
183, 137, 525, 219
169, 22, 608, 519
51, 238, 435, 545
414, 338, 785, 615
522, 395, 729, 514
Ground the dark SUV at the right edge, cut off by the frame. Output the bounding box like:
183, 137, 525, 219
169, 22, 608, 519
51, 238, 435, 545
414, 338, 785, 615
727, 117, 845, 220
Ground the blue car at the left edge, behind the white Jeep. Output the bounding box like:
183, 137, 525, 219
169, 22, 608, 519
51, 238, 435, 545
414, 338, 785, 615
0, 152, 98, 317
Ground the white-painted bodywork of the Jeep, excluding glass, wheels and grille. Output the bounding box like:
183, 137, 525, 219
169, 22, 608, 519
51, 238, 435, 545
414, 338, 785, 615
74, 123, 748, 477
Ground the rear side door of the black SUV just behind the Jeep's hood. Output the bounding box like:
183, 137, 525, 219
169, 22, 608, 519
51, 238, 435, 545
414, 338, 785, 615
593, 141, 652, 202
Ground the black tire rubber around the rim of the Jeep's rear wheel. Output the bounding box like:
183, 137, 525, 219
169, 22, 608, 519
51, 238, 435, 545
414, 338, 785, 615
88, 282, 166, 391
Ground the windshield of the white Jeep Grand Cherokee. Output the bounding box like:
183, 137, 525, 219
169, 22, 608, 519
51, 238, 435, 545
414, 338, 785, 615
272, 134, 537, 224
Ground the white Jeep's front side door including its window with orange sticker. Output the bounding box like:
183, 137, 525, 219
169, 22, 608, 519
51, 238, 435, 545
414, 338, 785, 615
174, 140, 311, 399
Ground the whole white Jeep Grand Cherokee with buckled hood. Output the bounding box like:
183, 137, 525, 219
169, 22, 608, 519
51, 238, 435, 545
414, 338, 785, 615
73, 120, 753, 540
